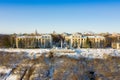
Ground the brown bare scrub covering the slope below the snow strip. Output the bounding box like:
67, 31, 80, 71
0, 52, 120, 80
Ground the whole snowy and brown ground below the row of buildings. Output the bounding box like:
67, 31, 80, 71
0, 49, 120, 80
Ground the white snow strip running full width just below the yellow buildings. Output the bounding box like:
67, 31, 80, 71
0, 49, 120, 58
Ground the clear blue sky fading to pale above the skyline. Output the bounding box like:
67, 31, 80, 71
0, 0, 120, 33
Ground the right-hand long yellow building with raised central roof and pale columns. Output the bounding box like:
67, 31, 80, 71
65, 33, 105, 48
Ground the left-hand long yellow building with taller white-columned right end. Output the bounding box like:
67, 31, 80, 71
16, 35, 52, 48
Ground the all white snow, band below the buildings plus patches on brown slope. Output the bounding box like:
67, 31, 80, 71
0, 49, 120, 80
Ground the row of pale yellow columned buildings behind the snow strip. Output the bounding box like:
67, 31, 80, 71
14, 33, 120, 49
